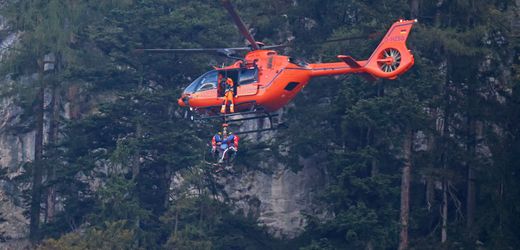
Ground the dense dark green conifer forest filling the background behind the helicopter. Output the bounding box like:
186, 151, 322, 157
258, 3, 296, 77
0, 0, 520, 250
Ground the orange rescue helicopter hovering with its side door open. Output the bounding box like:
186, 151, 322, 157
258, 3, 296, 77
143, 0, 417, 132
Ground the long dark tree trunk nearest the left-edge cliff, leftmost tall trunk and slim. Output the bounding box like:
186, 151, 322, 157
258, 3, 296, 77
29, 61, 45, 242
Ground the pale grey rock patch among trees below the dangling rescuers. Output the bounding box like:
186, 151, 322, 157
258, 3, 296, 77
224, 156, 327, 238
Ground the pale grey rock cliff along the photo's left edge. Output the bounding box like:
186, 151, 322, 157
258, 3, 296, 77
0, 15, 34, 249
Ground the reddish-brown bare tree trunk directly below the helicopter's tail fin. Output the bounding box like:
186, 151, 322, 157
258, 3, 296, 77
398, 131, 413, 250
